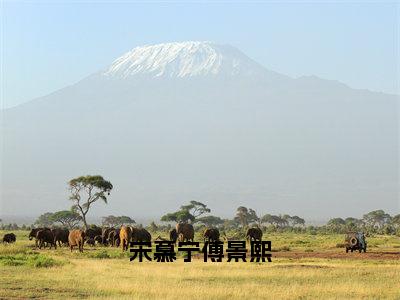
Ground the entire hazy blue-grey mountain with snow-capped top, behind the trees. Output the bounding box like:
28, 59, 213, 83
0, 42, 399, 218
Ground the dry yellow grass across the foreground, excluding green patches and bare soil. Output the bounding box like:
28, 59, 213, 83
0, 231, 400, 299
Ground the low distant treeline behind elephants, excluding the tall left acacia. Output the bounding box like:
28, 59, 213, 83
0, 201, 400, 236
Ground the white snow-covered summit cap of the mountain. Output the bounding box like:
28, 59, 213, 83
102, 41, 265, 78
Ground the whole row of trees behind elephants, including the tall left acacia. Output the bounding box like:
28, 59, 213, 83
0, 175, 400, 235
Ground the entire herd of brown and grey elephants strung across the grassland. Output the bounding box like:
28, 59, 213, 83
3, 223, 262, 252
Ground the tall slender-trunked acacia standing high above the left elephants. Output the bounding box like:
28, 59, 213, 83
68, 175, 113, 229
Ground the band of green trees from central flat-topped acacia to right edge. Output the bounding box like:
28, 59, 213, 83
161, 201, 400, 236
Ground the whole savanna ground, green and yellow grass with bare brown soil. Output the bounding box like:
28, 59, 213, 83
0, 231, 400, 299
